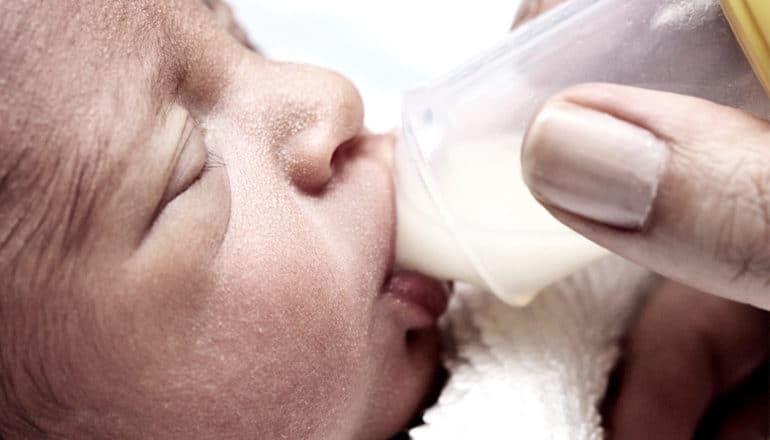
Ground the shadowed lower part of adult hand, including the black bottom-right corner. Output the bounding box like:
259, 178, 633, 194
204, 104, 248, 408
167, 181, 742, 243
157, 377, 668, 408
603, 281, 770, 440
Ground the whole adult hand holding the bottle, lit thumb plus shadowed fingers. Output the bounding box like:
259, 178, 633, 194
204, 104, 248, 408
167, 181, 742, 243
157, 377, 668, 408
517, 0, 770, 440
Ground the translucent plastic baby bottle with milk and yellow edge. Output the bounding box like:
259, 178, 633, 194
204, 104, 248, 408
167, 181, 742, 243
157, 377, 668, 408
395, 0, 770, 305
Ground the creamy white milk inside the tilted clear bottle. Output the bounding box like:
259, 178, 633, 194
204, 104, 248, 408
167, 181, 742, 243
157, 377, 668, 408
396, 136, 607, 305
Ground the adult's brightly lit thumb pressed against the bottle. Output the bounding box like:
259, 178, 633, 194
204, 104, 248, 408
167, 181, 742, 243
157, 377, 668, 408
522, 84, 770, 309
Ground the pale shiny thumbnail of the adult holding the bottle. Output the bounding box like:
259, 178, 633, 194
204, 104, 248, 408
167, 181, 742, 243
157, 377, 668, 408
522, 102, 668, 229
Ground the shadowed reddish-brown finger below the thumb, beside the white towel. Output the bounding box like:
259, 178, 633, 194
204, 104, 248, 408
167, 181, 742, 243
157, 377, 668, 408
607, 282, 770, 440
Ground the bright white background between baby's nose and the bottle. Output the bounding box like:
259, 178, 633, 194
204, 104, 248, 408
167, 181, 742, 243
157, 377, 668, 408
222, 0, 520, 131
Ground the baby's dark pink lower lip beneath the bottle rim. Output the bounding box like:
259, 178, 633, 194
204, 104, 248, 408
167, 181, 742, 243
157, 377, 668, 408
385, 271, 449, 328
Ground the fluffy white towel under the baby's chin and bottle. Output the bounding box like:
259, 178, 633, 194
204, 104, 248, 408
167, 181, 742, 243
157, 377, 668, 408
410, 257, 655, 440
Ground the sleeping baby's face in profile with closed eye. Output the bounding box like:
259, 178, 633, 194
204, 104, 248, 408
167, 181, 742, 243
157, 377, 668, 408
0, 0, 441, 439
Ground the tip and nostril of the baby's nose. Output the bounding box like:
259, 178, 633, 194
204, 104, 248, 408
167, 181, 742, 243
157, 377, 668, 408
282, 67, 364, 192
